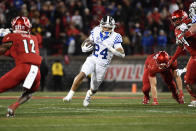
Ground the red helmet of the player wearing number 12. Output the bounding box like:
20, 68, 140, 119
11, 16, 32, 33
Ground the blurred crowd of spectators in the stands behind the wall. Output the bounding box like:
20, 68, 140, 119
0, 0, 193, 56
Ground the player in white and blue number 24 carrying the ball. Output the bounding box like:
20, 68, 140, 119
63, 16, 125, 107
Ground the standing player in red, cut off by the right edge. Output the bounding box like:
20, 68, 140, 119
170, 10, 196, 98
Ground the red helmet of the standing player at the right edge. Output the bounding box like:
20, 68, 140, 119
171, 10, 188, 27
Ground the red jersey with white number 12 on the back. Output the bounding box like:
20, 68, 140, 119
2, 33, 42, 65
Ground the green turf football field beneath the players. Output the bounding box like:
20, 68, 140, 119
0, 92, 196, 131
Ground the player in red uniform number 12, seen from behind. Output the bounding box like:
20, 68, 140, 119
0, 16, 42, 117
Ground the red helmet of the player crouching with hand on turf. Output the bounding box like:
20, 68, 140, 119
156, 51, 169, 68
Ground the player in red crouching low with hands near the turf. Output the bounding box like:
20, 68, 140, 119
142, 51, 184, 105
